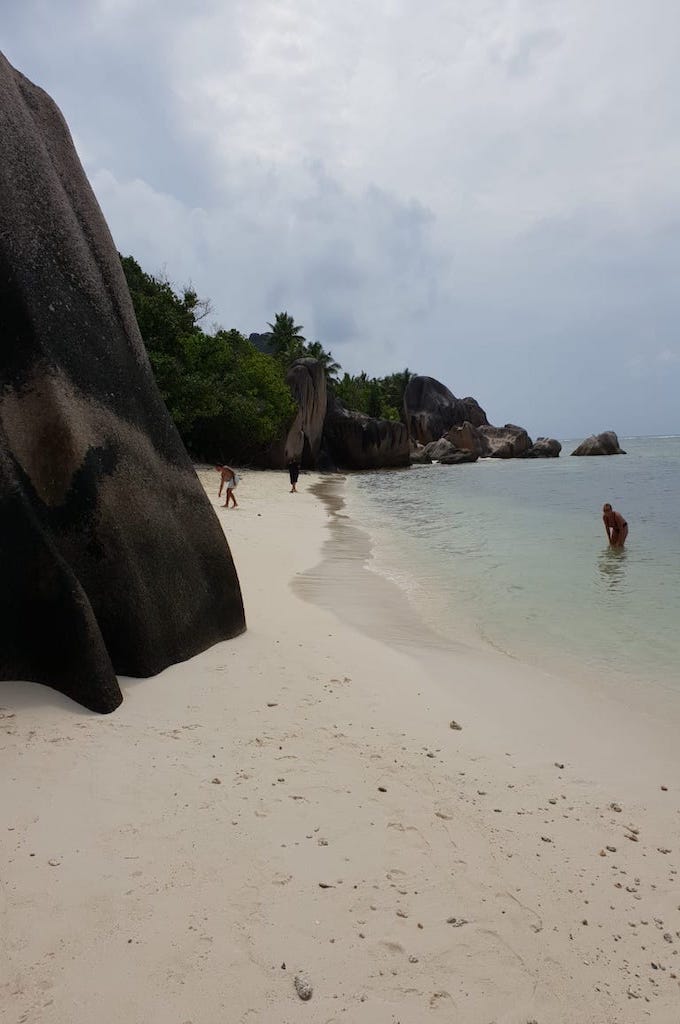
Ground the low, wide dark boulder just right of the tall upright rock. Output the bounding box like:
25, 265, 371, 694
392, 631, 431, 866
324, 397, 411, 469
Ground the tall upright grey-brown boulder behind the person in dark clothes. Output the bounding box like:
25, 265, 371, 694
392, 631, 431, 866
268, 358, 328, 469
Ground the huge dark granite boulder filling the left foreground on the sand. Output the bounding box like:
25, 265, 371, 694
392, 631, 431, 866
0, 54, 245, 712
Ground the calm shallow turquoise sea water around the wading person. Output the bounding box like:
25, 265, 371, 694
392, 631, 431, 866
347, 437, 680, 690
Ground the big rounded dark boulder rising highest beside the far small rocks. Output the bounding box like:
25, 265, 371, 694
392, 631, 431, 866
403, 376, 488, 444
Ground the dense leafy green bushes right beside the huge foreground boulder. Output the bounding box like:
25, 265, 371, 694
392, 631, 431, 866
122, 256, 296, 463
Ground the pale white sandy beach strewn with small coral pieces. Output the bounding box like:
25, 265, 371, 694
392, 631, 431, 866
0, 471, 680, 1024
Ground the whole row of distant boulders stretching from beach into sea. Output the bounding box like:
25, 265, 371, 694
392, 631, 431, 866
278, 358, 625, 470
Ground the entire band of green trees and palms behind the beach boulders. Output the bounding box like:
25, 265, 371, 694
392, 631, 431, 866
121, 256, 413, 464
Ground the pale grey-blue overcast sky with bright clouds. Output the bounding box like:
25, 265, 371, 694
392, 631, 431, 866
0, 0, 680, 437
